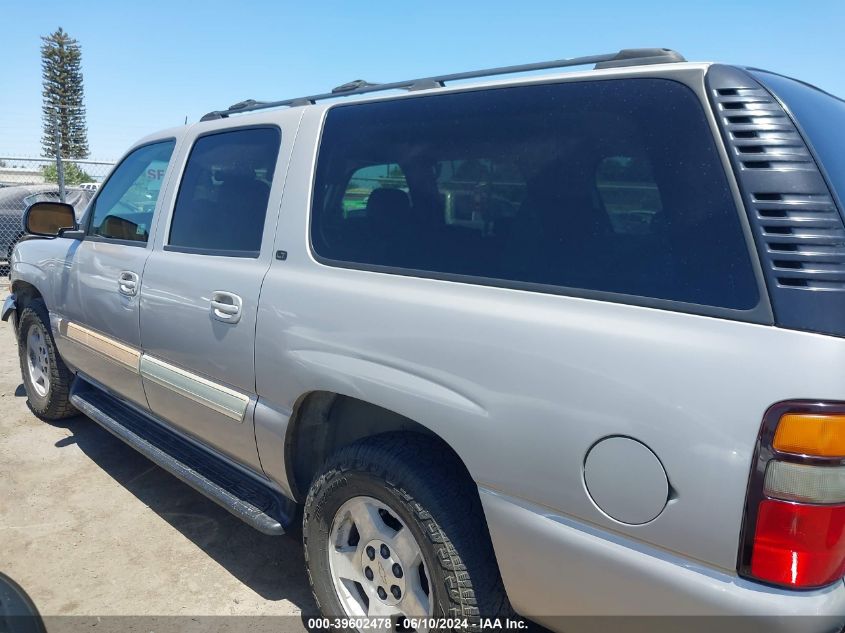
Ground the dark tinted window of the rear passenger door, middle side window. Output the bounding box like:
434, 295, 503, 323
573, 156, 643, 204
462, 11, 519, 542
169, 127, 281, 257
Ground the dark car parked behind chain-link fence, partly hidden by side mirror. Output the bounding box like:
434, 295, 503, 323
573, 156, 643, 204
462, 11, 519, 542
0, 184, 96, 274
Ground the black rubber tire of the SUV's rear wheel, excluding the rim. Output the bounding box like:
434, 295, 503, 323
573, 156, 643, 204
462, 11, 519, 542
302, 433, 513, 630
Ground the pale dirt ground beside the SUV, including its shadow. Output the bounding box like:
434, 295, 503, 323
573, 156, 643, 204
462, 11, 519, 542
0, 286, 315, 631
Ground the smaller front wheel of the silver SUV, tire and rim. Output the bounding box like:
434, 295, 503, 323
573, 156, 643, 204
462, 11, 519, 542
18, 299, 77, 420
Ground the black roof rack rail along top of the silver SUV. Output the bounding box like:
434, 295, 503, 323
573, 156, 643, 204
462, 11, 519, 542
200, 48, 686, 121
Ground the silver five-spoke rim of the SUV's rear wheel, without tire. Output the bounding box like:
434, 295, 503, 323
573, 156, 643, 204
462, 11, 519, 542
328, 496, 434, 631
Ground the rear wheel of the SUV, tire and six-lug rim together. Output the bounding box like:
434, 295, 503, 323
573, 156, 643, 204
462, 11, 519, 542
302, 434, 510, 631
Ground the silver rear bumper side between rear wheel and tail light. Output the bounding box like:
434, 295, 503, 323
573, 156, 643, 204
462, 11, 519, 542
479, 487, 845, 632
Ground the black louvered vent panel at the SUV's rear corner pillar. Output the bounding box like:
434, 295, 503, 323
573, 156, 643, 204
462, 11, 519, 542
707, 65, 845, 336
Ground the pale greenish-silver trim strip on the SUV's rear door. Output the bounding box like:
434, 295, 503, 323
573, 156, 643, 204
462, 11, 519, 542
141, 354, 249, 422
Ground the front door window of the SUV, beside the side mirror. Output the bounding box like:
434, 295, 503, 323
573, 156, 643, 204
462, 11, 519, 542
88, 141, 176, 242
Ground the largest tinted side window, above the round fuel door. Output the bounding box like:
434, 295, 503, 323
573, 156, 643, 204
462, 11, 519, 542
311, 79, 758, 309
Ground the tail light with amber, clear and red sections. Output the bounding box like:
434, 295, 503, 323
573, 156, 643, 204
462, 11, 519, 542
739, 402, 845, 589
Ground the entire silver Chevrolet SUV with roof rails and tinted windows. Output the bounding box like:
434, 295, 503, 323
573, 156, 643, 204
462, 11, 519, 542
2, 49, 845, 631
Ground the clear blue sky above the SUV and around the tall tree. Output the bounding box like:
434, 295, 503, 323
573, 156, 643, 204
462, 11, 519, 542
0, 0, 845, 159
